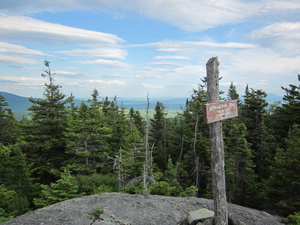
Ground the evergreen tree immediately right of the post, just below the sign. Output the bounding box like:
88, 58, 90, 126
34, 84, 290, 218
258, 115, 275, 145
224, 119, 256, 206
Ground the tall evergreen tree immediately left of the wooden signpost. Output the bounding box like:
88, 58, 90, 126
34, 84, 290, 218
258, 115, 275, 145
170, 85, 211, 195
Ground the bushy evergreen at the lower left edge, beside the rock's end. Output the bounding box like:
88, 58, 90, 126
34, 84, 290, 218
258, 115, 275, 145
0, 144, 37, 221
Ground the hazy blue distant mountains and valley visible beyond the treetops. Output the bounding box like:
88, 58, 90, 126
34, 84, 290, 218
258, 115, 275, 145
0, 92, 282, 120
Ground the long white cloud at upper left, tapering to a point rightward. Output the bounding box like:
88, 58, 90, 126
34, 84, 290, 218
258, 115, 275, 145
0, 14, 123, 45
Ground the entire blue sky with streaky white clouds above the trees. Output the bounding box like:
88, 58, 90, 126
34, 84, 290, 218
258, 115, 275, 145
0, 0, 300, 98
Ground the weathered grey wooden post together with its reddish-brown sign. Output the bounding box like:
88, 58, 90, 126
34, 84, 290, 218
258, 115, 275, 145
204, 57, 238, 225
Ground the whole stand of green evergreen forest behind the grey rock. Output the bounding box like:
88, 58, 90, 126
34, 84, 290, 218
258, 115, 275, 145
0, 62, 300, 221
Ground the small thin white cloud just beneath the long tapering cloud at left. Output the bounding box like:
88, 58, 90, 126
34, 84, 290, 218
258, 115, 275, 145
57, 48, 128, 59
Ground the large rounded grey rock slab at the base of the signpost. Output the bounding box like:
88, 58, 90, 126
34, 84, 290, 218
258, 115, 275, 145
1, 193, 281, 225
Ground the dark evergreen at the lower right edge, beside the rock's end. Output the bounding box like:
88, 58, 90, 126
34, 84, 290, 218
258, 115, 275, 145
268, 124, 300, 216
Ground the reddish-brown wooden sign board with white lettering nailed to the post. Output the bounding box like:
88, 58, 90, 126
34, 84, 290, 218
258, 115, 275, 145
203, 100, 238, 124
